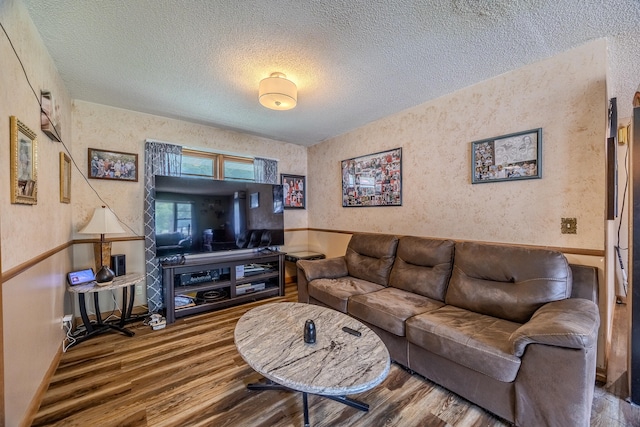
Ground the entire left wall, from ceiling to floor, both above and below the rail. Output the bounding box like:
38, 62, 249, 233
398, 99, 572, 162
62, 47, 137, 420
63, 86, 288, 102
0, 0, 73, 426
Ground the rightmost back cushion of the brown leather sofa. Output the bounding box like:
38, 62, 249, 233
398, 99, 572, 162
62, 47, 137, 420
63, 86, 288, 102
445, 242, 572, 323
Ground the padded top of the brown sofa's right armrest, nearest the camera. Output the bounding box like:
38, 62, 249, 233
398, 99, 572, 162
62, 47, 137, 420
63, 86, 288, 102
509, 298, 600, 357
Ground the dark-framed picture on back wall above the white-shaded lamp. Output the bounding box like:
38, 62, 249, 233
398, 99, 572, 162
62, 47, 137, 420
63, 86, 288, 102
89, 148, 138, 181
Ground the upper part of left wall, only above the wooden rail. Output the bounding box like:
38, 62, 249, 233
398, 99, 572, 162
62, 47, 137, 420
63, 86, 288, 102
0, 1, 71, 271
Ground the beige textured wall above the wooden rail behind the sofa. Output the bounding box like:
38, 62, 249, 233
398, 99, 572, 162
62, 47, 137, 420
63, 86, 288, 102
308, 40, 607, 250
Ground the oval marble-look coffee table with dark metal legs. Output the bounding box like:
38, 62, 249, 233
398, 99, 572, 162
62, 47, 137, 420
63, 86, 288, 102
234, 302, 390, 426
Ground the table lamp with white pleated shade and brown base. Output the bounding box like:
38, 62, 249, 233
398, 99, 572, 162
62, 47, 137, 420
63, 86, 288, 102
80, 206, 125, 283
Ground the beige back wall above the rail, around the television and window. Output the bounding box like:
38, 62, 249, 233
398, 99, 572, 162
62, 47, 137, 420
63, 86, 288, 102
72, 100, 307, 241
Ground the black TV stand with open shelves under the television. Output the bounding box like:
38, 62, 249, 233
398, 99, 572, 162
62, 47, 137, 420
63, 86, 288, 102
161, 251, 285, 323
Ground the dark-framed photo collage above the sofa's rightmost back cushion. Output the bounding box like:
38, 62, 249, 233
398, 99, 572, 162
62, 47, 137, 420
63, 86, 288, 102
471, 128, 542, 184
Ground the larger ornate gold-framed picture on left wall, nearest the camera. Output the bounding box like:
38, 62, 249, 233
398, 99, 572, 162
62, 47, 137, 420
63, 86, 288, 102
9, 116, 38, 205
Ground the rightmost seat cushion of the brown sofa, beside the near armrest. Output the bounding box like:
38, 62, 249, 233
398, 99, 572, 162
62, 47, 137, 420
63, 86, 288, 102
406, 305, 521, 382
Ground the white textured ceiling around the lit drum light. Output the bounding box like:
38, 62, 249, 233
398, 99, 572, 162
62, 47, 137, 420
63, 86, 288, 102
22, 0, 640, 145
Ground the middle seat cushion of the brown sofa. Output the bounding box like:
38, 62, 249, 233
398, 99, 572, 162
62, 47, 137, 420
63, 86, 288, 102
347, 288, 444, 337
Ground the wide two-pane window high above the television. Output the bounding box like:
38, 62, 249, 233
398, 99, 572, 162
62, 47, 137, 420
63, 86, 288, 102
182, 148, 255, 181
